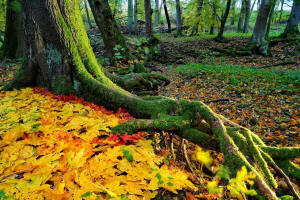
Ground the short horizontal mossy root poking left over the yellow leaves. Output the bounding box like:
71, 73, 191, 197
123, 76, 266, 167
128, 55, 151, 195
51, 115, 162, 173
112, 116, 190, 134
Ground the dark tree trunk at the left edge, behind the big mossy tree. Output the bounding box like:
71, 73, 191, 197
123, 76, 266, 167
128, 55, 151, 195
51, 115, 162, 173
0, 0, 24, 59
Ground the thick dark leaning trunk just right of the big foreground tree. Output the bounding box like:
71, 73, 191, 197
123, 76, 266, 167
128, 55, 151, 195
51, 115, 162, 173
88, 0, 129, 58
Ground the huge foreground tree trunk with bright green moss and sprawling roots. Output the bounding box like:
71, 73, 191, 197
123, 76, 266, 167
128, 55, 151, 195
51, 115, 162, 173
4, 0, 300, 199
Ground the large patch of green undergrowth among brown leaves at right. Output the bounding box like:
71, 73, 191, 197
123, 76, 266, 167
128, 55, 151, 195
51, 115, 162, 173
174, 64, 300, 95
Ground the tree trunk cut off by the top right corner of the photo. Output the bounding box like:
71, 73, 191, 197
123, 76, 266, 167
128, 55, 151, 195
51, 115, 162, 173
281, 0, 300, 37
